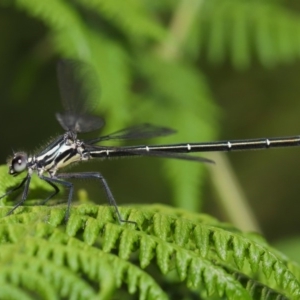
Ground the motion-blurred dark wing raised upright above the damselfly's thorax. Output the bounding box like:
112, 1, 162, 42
56, 60, 104, 132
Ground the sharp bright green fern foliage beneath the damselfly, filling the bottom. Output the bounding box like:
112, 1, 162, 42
0, 204, 300, 299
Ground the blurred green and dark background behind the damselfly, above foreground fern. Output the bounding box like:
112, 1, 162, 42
0, 0, 300, 255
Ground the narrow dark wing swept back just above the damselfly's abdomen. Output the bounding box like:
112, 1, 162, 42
86, 123, 176, 145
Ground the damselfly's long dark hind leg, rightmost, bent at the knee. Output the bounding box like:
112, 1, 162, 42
56, 172, 136, 224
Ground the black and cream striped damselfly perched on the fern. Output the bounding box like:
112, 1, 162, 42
0, 60, 300, 222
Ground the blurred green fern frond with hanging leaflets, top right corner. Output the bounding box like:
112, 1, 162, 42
197, 0, 300, 69
